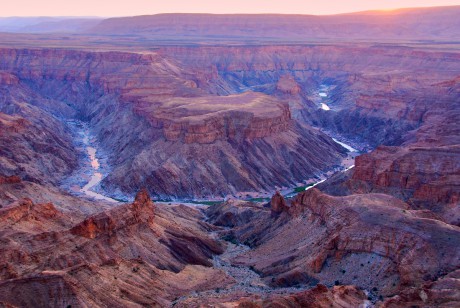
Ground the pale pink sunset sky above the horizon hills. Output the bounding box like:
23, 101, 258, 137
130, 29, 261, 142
0, 0, 460, 17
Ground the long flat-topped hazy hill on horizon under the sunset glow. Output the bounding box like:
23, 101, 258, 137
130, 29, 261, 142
87, 6, 460, 40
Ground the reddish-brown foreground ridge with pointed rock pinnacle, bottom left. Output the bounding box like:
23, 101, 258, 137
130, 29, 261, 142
0, 190, 228, 307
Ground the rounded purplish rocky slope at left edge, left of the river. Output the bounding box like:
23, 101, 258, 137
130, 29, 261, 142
0, 110, 77, 184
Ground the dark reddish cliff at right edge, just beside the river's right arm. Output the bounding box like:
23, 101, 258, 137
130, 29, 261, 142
352, 146, 460, 206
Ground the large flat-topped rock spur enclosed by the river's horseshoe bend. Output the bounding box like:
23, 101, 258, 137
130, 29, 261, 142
0, 49, 344, 198
